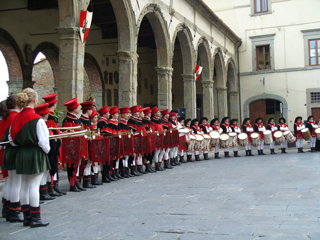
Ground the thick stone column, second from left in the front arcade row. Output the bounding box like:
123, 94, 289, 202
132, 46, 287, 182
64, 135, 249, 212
117, 51, 139, 108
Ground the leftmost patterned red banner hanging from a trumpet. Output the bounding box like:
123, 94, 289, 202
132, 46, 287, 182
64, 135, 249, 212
60, 137, 82, 166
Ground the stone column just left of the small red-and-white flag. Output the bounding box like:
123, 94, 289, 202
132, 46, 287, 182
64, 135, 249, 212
181, 74, 197, 119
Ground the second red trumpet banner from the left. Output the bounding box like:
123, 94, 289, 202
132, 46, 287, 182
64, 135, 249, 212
89, 138, 110, 164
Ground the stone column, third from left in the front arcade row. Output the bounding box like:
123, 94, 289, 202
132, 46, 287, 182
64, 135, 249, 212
155, 67, 173, 110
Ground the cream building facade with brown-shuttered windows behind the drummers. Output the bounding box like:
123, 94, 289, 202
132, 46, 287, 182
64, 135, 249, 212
205, 0, 320, 128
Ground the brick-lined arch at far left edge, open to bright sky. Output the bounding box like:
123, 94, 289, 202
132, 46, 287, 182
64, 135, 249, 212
0, 28, 24, 83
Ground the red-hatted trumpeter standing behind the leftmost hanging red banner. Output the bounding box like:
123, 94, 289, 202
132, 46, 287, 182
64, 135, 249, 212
62, 98, 87, 192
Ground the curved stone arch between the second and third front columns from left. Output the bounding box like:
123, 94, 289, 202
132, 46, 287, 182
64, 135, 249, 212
135, 3, 171, 68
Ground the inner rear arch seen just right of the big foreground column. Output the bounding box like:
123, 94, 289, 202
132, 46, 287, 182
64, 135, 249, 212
84, 53, 105, 107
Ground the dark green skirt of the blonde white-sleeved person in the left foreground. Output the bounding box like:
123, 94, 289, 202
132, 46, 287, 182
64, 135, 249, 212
16, 146, 50, 175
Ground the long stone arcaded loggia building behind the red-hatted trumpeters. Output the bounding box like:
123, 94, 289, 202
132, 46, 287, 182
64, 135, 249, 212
0, 0, 241, 118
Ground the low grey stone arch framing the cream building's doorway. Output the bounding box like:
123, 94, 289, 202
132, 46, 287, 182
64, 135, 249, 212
243, 93, 288, 120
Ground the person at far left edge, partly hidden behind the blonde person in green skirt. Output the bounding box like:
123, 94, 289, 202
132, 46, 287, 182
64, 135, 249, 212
0, 94, 23, 222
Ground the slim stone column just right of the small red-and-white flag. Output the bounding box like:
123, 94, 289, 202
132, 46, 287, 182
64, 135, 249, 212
202, 80, 214, 119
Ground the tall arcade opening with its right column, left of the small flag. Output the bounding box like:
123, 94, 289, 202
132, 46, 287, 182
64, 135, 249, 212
172, 24, 196, 118
